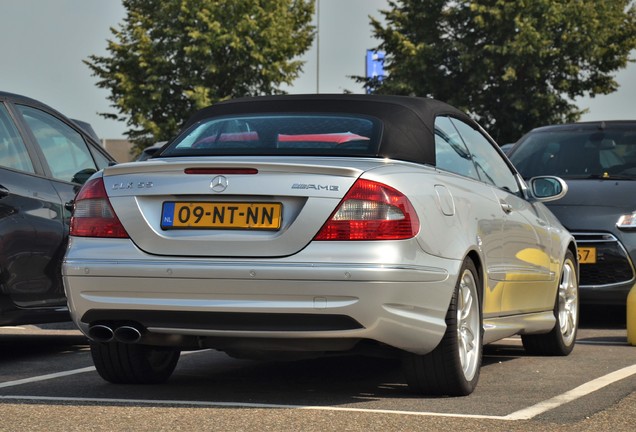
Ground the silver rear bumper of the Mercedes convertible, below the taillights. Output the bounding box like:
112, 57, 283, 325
63, 240, 461, 354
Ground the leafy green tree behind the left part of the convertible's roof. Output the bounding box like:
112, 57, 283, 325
85, 0, 314, 152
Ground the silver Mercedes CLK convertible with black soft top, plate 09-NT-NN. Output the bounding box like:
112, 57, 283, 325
63, 95, 579, 395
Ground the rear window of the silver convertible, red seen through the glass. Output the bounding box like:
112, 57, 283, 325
161, 114, 381, 157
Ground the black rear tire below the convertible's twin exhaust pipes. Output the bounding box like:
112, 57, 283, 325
90, 342, 181, 384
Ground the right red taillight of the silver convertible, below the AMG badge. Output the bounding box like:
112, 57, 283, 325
314, 180, 420, 240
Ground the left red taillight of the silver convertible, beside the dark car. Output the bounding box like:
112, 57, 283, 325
70, 177, 128, 238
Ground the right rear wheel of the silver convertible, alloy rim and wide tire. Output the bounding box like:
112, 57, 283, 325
402, 259, 483, 396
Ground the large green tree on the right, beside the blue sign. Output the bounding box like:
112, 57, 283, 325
356, 0, 636, 143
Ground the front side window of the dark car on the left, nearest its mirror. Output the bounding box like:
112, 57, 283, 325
18, 105, 97, 183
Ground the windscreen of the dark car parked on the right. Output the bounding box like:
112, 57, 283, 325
509, 125, 636, 179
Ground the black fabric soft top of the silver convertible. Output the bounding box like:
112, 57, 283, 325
185, 94, 476, 164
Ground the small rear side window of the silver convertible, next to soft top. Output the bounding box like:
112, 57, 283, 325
435, 117, 479, 180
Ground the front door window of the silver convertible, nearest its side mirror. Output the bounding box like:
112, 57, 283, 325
451, 119, 519, 194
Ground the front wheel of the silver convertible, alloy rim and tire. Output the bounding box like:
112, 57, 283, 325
521, 251, 579, 356
